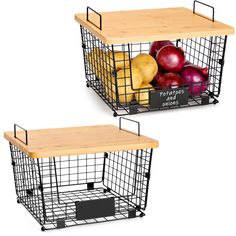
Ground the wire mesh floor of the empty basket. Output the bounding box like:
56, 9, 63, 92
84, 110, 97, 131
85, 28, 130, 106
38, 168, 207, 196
17, 188, 142, 231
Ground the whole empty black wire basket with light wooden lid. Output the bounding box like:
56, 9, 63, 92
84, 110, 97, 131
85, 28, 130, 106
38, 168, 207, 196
5, 119, 158, 231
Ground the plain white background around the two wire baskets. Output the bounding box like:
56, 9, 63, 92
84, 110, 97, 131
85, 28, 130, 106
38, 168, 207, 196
0, 0, 236, 236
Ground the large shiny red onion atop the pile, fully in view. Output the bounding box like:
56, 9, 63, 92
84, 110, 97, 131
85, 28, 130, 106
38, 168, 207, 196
156, 46, 185, 72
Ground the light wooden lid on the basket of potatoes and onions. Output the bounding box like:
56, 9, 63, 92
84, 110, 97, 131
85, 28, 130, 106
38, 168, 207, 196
75, 8, 234, 44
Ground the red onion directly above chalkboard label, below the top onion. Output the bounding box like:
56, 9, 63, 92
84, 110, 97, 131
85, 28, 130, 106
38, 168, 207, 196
157, 72, 182, 90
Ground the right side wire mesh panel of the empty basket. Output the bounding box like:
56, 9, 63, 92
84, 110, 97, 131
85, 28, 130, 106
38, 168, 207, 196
104, 150, 152, 210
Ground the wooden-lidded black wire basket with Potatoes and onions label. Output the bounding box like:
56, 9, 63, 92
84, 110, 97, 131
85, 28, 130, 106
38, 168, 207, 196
75, 1, 234, 116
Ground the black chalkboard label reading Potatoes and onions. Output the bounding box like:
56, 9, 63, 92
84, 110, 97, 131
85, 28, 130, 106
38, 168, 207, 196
150, 88, 189, 109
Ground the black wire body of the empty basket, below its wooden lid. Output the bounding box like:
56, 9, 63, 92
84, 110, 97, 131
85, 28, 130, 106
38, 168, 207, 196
10, 119, 152, 231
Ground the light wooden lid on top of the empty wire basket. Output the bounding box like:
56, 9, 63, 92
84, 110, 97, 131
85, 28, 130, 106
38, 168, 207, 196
4, 125, 158, 158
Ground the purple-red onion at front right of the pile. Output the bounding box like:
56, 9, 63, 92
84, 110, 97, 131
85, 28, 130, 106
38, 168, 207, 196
180, 65, 208, 97
